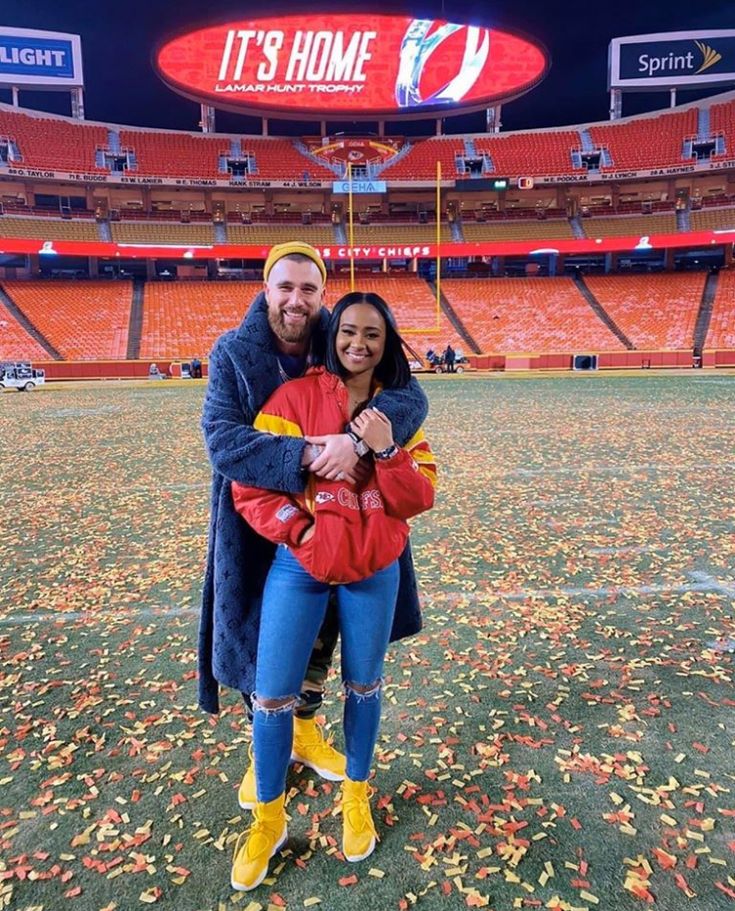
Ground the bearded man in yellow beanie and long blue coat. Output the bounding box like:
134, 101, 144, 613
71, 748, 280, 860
199, 242, 427, 828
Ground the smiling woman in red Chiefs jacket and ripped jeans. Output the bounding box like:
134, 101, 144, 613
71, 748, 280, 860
232, 292, 436, 891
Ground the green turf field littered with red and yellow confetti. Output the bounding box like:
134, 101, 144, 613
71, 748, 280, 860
0, 374, 735, 911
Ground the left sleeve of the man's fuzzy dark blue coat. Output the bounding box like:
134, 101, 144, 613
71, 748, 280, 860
201, 338, 304, 493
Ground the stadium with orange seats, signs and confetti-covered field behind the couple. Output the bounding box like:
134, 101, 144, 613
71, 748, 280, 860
0, 7, 735, 911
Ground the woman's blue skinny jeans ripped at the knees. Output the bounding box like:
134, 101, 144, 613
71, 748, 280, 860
253, 545, 399, 802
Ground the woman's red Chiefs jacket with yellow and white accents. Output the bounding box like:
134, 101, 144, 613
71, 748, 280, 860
232, 367, 436, 584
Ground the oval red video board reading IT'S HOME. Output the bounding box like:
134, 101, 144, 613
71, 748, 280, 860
154, 13, 549, 120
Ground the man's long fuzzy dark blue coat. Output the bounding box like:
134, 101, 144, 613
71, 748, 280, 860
199, 293, 427, 712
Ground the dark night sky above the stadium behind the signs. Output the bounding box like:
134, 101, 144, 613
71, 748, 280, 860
0, 0, 733, 135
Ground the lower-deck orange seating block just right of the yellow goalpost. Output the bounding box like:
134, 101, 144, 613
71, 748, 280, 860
442, 277, 624, 354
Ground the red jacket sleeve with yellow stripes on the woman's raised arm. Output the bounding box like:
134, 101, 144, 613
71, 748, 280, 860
375, 430, 436, 519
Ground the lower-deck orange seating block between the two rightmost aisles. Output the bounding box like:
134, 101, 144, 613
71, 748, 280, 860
585, 272, 705, 351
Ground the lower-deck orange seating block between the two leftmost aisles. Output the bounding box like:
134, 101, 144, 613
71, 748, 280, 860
3, 281, 132, 360
